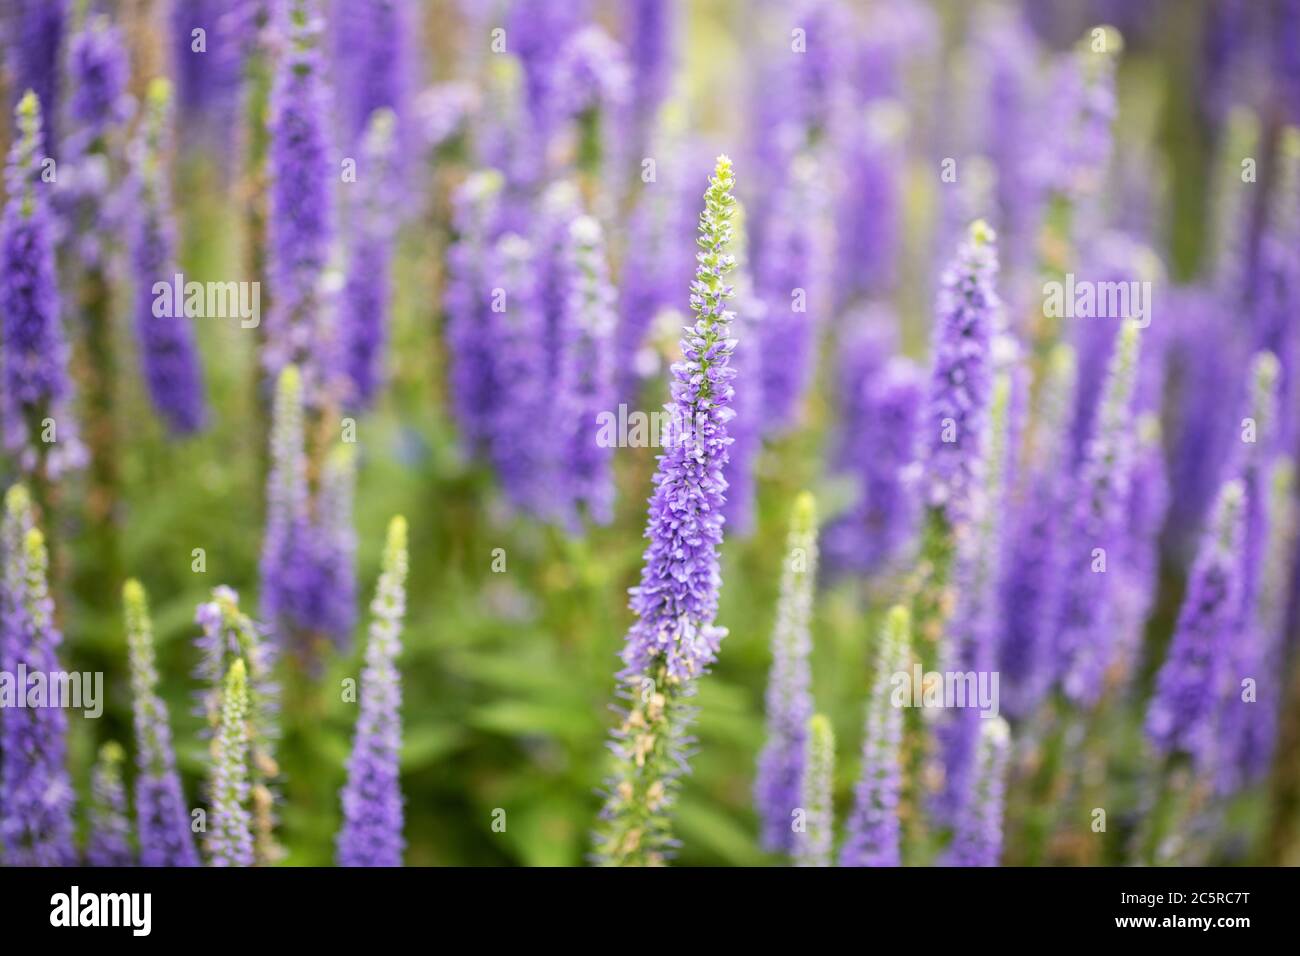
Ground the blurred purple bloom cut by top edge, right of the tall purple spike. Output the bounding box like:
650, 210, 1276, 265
332, 0, 419, 140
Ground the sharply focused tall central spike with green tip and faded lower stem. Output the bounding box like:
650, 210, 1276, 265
595, 156, 736, 865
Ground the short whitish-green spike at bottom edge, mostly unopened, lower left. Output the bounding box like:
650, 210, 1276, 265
207, 658, 254, 866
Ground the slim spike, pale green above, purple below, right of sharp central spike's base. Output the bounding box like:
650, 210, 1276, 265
754, 492, 818, 853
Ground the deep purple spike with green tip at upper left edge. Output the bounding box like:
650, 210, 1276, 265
0, 91, 83, 478
